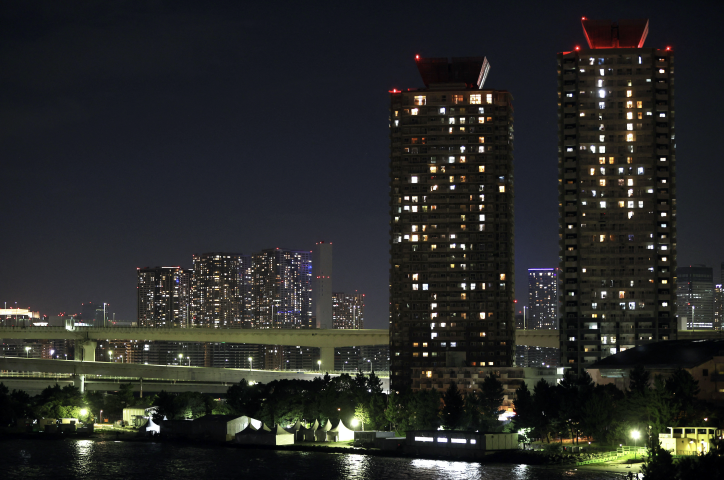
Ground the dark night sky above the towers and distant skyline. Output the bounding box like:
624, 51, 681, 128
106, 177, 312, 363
0, 1, 724, 327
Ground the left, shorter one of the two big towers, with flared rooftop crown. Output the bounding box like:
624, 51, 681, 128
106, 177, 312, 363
390, 56, 515, 390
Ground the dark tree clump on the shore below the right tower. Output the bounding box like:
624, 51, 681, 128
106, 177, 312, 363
514, 367, 714, 444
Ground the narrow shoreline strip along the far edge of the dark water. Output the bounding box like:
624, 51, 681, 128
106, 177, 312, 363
0, 432, 643, 475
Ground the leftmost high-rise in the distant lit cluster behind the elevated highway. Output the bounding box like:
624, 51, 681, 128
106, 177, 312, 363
137, 267, 190, 328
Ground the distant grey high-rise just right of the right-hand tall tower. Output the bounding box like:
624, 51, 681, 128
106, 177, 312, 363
676, 265, 714, 329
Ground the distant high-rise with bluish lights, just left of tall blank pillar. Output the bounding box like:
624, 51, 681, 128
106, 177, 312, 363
252, 248, 312, 328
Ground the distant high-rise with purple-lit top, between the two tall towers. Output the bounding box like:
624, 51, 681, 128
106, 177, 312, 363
526, 268, 560, 330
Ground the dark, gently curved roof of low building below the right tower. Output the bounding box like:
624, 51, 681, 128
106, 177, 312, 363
589, 339, 724, 370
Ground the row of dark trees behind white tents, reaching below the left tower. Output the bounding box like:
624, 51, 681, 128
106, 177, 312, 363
153, 373, 504, 432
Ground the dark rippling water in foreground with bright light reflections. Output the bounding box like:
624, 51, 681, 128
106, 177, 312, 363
0, 439, 621, 480
